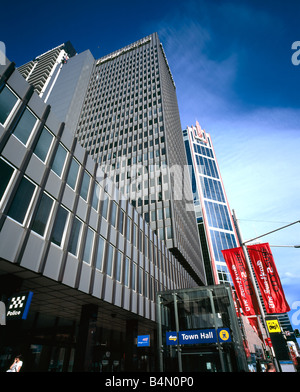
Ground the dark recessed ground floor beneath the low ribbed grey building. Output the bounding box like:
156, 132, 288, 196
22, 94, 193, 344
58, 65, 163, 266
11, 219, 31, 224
0, 260, 157, 373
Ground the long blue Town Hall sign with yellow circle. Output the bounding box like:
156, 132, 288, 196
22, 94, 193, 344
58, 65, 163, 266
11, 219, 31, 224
166, 328, 231, 346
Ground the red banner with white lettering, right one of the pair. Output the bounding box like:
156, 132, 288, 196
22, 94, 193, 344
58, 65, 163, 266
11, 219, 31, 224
247, 243, 290, 314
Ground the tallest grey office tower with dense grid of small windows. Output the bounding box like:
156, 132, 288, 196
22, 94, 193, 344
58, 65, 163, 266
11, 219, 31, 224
76, 33, 206, 285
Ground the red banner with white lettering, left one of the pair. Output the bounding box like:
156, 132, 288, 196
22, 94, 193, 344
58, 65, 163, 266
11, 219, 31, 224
222, 248, 259, 316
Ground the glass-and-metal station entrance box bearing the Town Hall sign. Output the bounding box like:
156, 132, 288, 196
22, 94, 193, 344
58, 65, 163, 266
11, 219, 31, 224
158, 284, 248, 372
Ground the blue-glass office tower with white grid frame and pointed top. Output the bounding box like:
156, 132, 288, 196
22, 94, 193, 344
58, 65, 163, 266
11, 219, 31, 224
183, 122, 238, 284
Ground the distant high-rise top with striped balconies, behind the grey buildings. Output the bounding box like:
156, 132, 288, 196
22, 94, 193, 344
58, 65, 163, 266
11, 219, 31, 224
18, 41, 76, 102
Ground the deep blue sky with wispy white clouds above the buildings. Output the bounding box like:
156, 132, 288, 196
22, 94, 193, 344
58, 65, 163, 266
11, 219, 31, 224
0, 0, 300, 336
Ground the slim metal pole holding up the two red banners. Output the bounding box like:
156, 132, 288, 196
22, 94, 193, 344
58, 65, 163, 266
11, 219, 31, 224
232, 210, 280, 372
